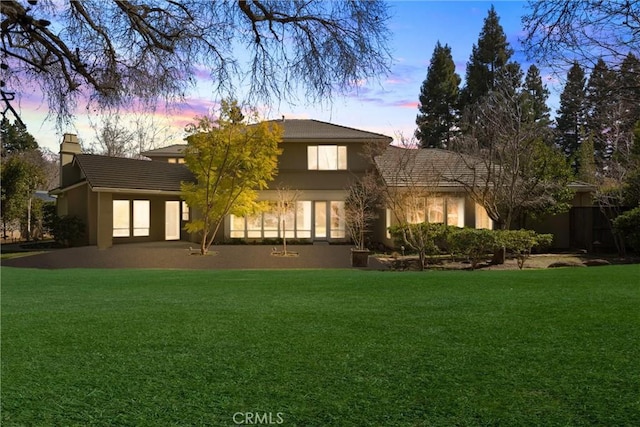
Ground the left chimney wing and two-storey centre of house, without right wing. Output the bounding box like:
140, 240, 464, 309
52, 119, 392, 248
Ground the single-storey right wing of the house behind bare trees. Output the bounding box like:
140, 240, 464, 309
375, 146, 594, 250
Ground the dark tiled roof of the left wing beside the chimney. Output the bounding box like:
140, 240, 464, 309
75, 154, 194, 191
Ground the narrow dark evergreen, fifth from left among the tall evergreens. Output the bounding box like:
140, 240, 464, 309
586, 59, 621, 160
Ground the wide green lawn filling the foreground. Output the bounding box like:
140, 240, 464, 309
1, 265, 640, 426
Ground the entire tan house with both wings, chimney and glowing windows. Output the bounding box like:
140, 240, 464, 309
52, 118, 590, 248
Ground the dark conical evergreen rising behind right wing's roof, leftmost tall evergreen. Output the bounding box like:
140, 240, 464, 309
416, 42, 460, 148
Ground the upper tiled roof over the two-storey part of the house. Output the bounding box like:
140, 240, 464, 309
141, 119, 393, 157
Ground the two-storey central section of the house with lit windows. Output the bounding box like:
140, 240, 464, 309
142, 118, 392, 242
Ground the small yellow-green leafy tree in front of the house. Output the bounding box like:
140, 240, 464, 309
182, 100, 282, 255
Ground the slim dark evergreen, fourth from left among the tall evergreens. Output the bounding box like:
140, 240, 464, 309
556, 62, 587, 165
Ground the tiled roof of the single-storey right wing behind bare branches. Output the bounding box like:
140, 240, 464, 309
375, 146, 486, 187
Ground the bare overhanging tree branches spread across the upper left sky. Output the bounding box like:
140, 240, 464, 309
0, 0, 390, 123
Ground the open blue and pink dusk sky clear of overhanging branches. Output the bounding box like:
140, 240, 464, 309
12, 1, 561, 152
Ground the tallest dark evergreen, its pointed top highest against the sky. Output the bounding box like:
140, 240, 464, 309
460, 6, 513, 109
